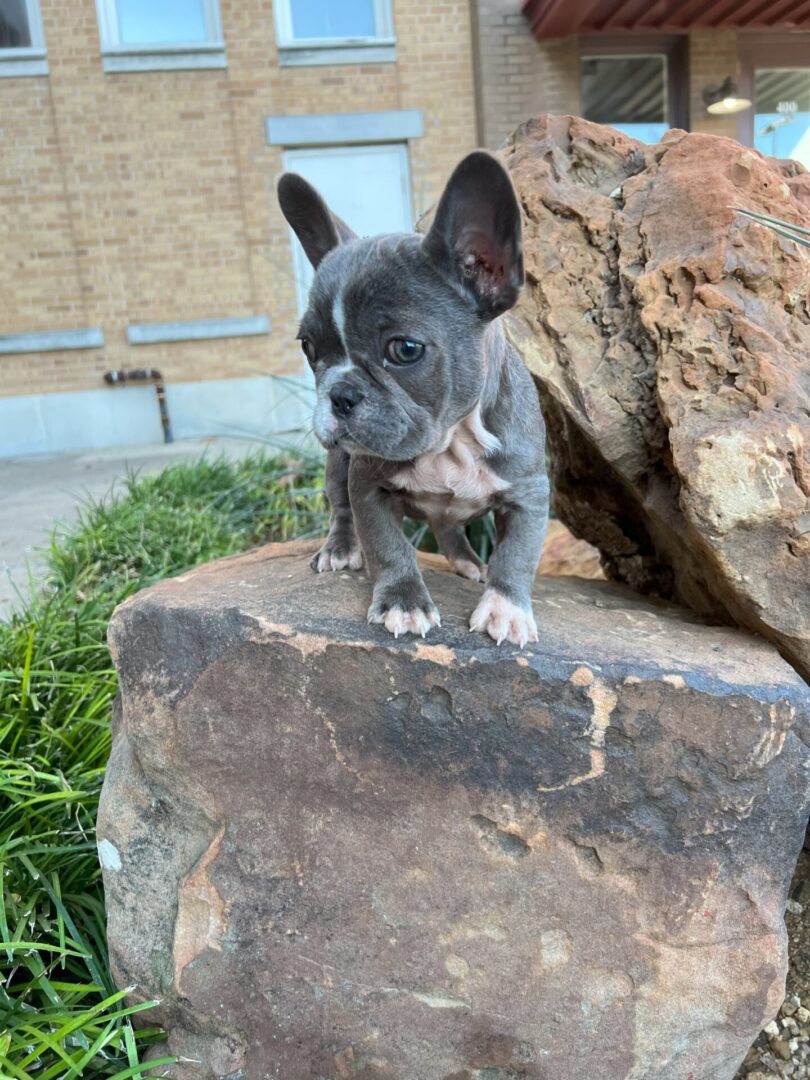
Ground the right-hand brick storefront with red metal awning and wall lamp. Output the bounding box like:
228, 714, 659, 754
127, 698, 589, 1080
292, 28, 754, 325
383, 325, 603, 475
475, 0, 810, 159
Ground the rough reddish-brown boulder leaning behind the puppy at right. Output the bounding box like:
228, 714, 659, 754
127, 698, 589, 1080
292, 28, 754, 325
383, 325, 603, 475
503, 117, 810, 679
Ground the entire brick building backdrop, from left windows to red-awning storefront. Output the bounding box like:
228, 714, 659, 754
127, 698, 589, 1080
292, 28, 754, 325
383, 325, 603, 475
0, 0, 810, 456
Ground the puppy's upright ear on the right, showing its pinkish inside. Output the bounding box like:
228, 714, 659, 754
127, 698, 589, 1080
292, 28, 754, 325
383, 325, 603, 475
422, 150, 524, 319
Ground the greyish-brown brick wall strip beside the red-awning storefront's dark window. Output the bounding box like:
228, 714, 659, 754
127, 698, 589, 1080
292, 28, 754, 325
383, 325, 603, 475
473, 0, 580, 148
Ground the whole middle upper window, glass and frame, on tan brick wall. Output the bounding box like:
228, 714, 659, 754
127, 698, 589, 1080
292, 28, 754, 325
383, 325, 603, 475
97, 0, 226, 71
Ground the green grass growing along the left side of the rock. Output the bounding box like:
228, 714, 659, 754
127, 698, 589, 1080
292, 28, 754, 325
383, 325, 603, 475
0, 456, 326, 1080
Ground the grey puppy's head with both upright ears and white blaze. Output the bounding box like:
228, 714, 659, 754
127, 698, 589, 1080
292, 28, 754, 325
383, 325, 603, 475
279, 151, 524, 461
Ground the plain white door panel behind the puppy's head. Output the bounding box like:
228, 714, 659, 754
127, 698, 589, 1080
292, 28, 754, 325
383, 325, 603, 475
284, 143, 414, 311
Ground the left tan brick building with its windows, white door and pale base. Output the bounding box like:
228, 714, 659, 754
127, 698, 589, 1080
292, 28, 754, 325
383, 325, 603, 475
0, 0, 476, 455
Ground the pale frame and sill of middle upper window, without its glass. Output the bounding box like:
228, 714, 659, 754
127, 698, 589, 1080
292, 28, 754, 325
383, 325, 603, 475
96, 0, 228, 73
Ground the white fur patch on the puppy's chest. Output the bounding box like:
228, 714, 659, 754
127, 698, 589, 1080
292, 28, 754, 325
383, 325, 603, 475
391, 408, 509, 522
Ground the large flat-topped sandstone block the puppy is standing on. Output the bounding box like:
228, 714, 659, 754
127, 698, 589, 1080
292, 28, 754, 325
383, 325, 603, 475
98, 545, 810, 1080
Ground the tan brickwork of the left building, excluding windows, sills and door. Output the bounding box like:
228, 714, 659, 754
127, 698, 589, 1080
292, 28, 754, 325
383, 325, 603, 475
0, 0, 476, 395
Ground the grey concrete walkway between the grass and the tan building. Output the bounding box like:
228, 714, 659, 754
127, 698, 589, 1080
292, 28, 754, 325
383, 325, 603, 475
0, 438, 270, 618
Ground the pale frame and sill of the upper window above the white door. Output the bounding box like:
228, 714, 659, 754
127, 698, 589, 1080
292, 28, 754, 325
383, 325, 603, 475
273, 0, 396, 66
